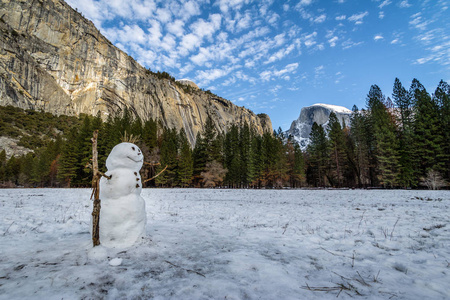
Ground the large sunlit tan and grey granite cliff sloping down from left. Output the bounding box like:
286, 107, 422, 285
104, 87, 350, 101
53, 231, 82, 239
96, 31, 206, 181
0, 0, 272, 144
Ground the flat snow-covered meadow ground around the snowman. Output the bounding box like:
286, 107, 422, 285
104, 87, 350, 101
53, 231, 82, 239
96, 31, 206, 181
0, 189, 450, 300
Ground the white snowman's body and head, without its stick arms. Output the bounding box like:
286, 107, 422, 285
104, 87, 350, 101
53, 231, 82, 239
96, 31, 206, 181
99, 143, 147, 248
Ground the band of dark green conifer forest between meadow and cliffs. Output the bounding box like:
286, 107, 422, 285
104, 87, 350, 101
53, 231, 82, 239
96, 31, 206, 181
0, 79, 450, 188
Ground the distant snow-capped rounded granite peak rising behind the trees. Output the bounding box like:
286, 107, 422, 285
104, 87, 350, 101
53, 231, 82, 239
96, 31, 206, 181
287, 103, 352, 150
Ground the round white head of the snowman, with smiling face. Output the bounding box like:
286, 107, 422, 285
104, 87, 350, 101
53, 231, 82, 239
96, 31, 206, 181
106, 143, 144, 171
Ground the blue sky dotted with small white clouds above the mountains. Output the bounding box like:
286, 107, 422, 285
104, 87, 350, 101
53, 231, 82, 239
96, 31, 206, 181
66, 0, 450, 130
